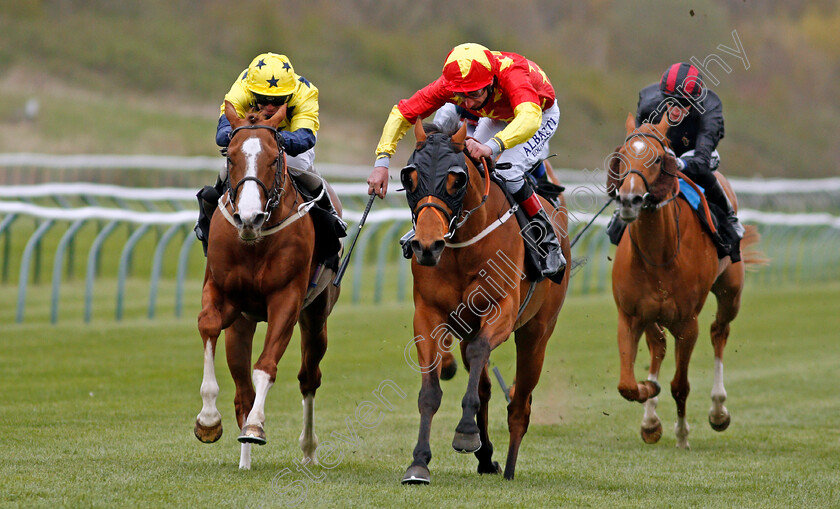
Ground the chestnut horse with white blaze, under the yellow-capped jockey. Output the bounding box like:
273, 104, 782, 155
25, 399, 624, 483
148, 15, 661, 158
195, 102, 341, 469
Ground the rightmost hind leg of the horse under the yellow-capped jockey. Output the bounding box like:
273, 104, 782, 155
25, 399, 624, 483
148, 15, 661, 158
298, 292, 330, 465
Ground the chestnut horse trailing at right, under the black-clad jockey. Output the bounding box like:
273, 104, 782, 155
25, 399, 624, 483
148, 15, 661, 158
608, 114, 760, 449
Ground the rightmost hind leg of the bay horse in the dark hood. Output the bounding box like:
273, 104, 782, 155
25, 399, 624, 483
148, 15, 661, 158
505, 321, 554, 480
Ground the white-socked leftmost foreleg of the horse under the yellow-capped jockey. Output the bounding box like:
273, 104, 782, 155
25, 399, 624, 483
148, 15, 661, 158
193, 282, 235, 443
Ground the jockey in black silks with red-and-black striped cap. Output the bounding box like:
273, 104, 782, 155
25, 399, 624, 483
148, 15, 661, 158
636, 62, 744, 238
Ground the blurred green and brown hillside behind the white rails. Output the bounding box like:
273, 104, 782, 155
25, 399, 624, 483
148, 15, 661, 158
0, 0, 840, 177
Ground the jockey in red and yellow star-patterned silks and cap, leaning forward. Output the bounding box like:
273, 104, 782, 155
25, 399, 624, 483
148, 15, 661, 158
368, 43, 565, 276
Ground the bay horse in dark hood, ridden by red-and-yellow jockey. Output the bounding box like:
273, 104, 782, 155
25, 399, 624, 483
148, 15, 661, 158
401, 120, 571, 484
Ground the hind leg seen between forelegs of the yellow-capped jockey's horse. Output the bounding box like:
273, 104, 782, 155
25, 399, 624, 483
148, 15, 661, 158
225, 315, 257, 470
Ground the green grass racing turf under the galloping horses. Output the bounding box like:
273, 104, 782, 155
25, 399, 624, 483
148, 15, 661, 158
0, 283, 840, 508
